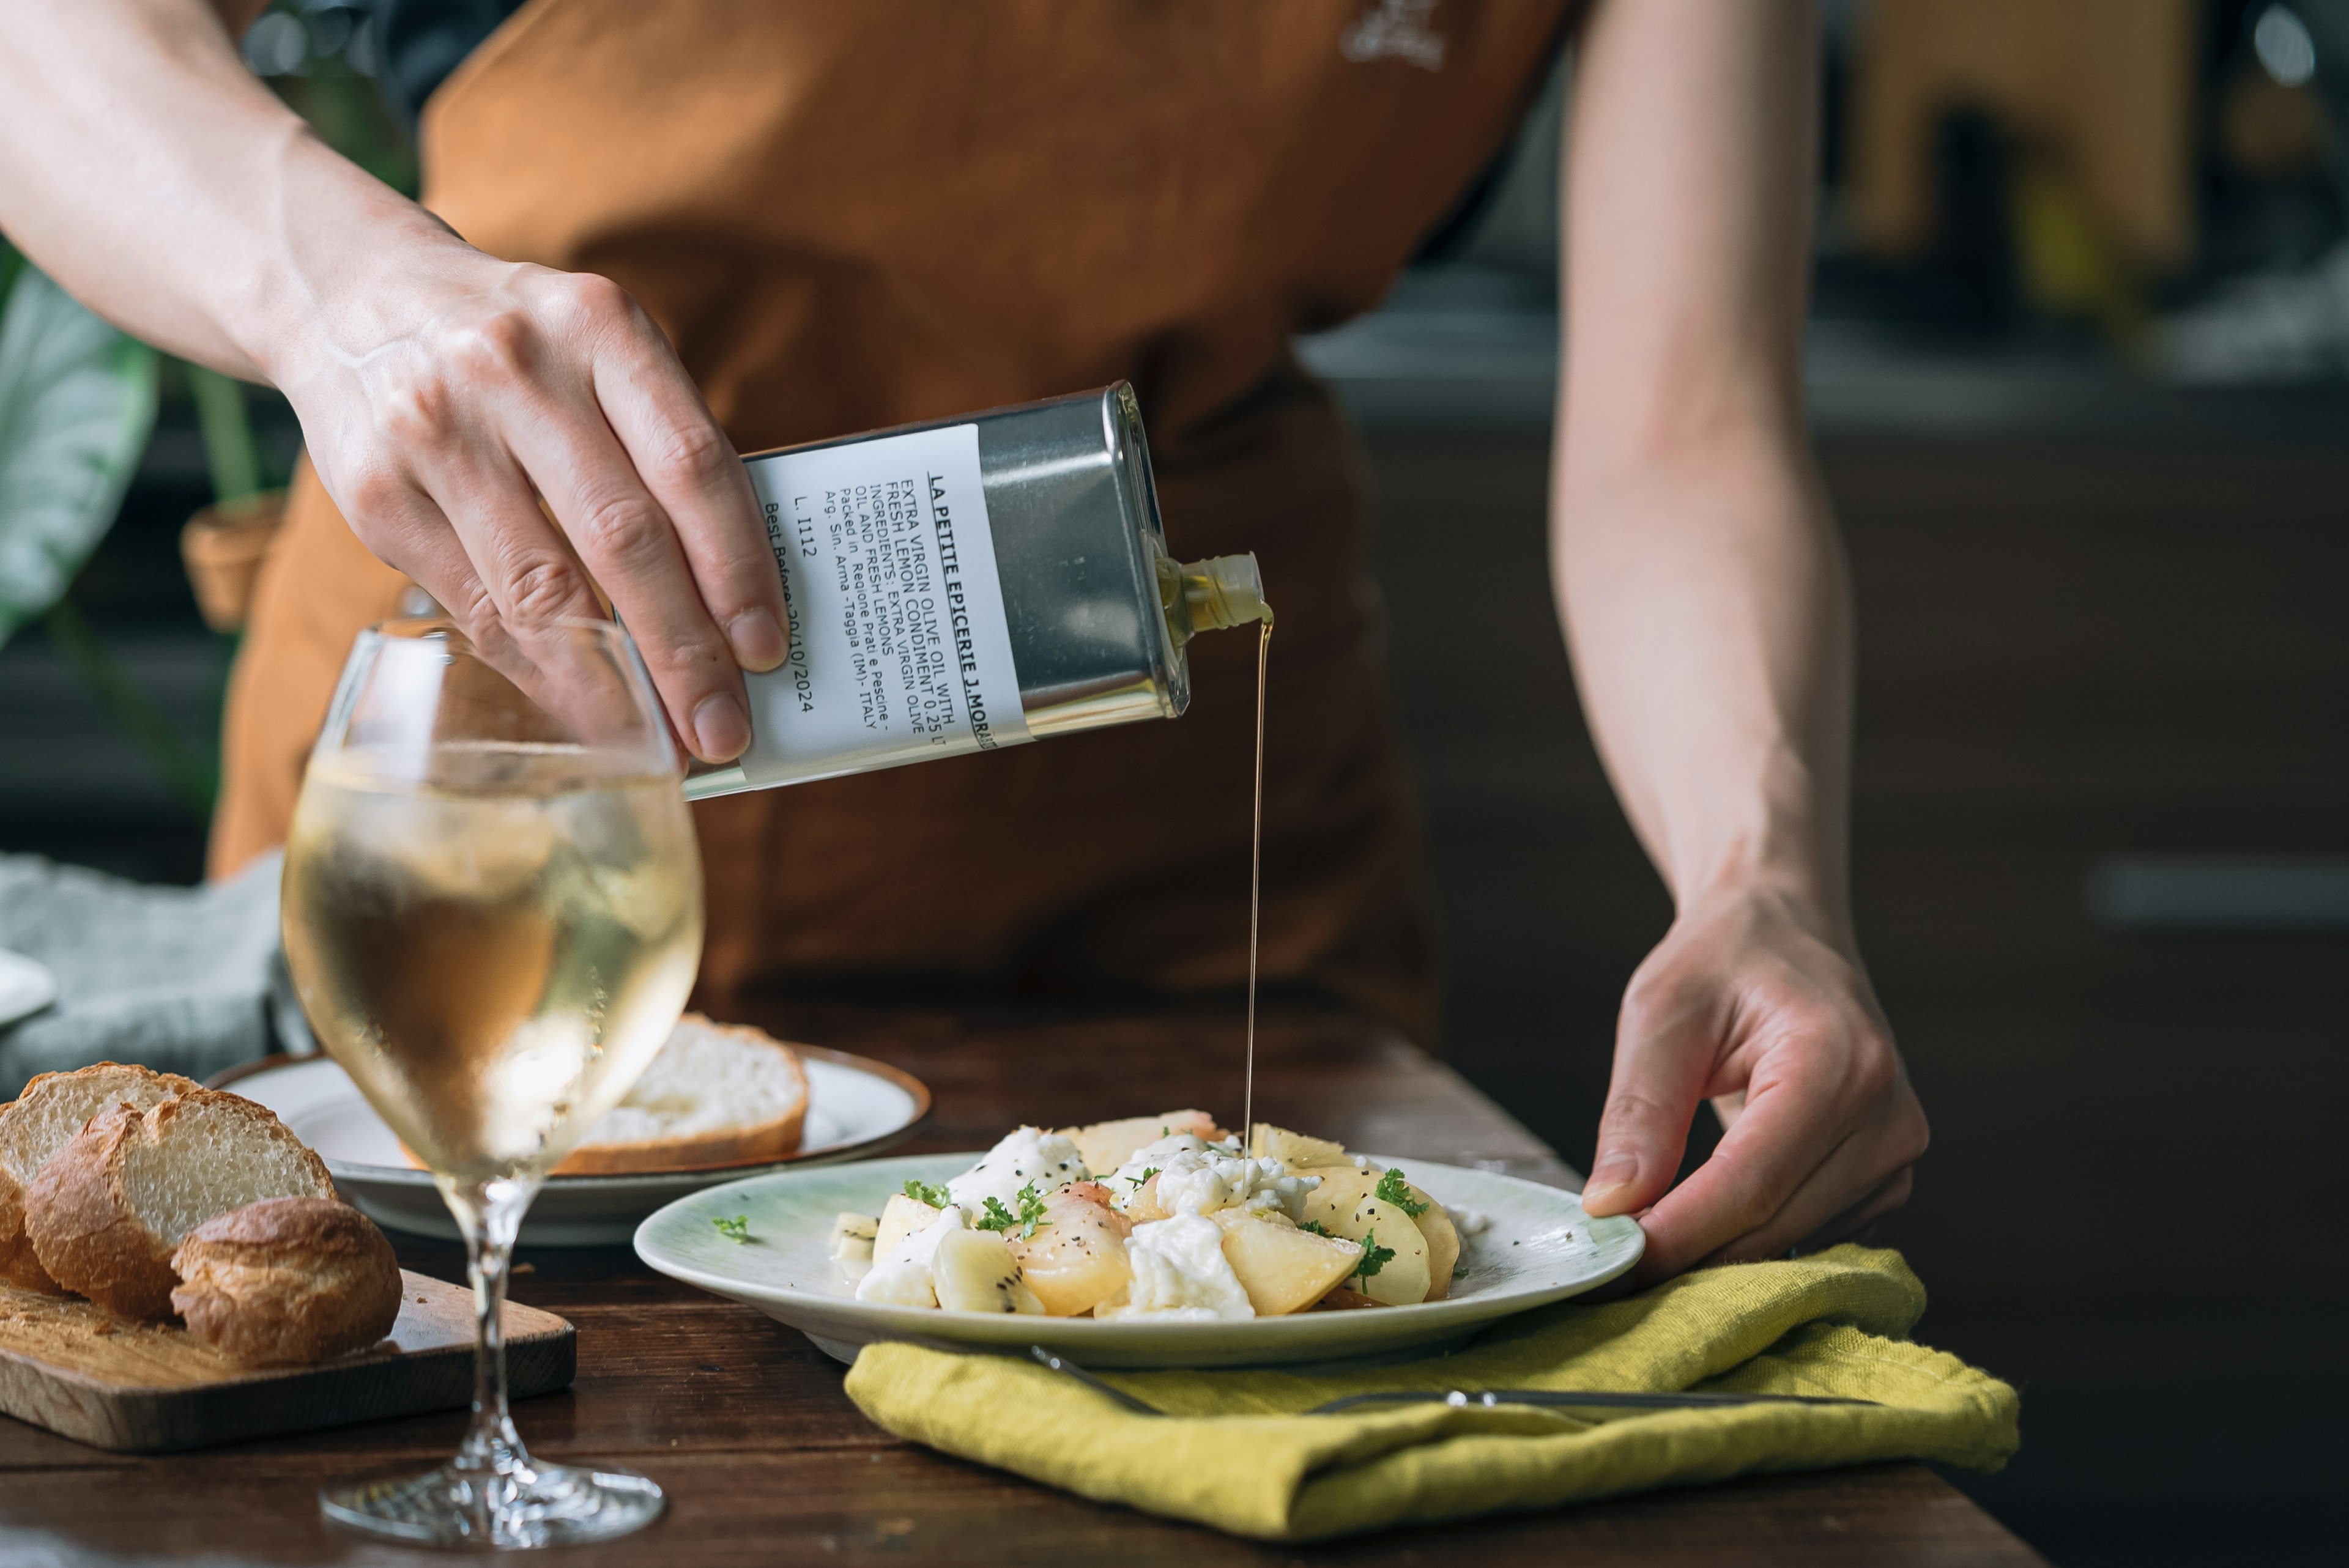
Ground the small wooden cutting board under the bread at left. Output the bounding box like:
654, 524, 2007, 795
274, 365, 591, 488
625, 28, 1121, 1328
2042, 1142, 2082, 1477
0, 1270, 578, 1453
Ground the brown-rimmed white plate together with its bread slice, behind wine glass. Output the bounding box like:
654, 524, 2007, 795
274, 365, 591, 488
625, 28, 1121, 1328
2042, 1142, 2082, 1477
212, 1014, 930, 1246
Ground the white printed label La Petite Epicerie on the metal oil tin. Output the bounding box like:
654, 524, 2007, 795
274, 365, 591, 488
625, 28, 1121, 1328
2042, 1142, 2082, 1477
742, 425, 1029, 784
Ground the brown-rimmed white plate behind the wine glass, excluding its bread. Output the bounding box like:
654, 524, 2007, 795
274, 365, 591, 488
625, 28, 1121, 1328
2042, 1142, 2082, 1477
212, 1045, 930, 1246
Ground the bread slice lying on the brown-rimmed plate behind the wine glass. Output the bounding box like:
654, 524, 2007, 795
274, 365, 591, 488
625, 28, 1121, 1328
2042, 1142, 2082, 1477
554, 1011, 808, 1176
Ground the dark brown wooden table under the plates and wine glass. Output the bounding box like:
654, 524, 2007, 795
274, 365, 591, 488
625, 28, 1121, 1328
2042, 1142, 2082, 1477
0, 1007, 2041, 1568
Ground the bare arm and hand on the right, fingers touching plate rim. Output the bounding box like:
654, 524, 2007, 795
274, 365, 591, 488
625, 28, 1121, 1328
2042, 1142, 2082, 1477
1553, 0, 1926, 1277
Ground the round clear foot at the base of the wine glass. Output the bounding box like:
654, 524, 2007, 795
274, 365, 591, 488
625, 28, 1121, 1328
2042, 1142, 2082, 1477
317, 1460, 667, 1549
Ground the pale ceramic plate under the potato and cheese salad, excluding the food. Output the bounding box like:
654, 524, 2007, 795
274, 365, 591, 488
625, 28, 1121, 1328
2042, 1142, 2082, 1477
637, 1155, 1647, 1366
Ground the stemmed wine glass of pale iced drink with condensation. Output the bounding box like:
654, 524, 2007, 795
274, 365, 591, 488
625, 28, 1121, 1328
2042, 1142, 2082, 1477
282, 619, 702, 1547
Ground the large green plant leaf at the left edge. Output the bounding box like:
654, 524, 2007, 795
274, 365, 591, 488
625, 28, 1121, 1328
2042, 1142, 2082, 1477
0, 246, 155, 643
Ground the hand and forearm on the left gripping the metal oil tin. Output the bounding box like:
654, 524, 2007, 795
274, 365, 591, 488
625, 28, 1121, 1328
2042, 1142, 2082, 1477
0, 0, 787, 761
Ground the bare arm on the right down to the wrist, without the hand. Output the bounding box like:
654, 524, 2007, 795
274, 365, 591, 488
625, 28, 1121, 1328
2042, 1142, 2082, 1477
1553, 0, 1851, 934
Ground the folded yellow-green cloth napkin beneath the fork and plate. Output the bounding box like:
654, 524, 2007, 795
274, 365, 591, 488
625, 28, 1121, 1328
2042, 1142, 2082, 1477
848, 1246, 2020, 1540
